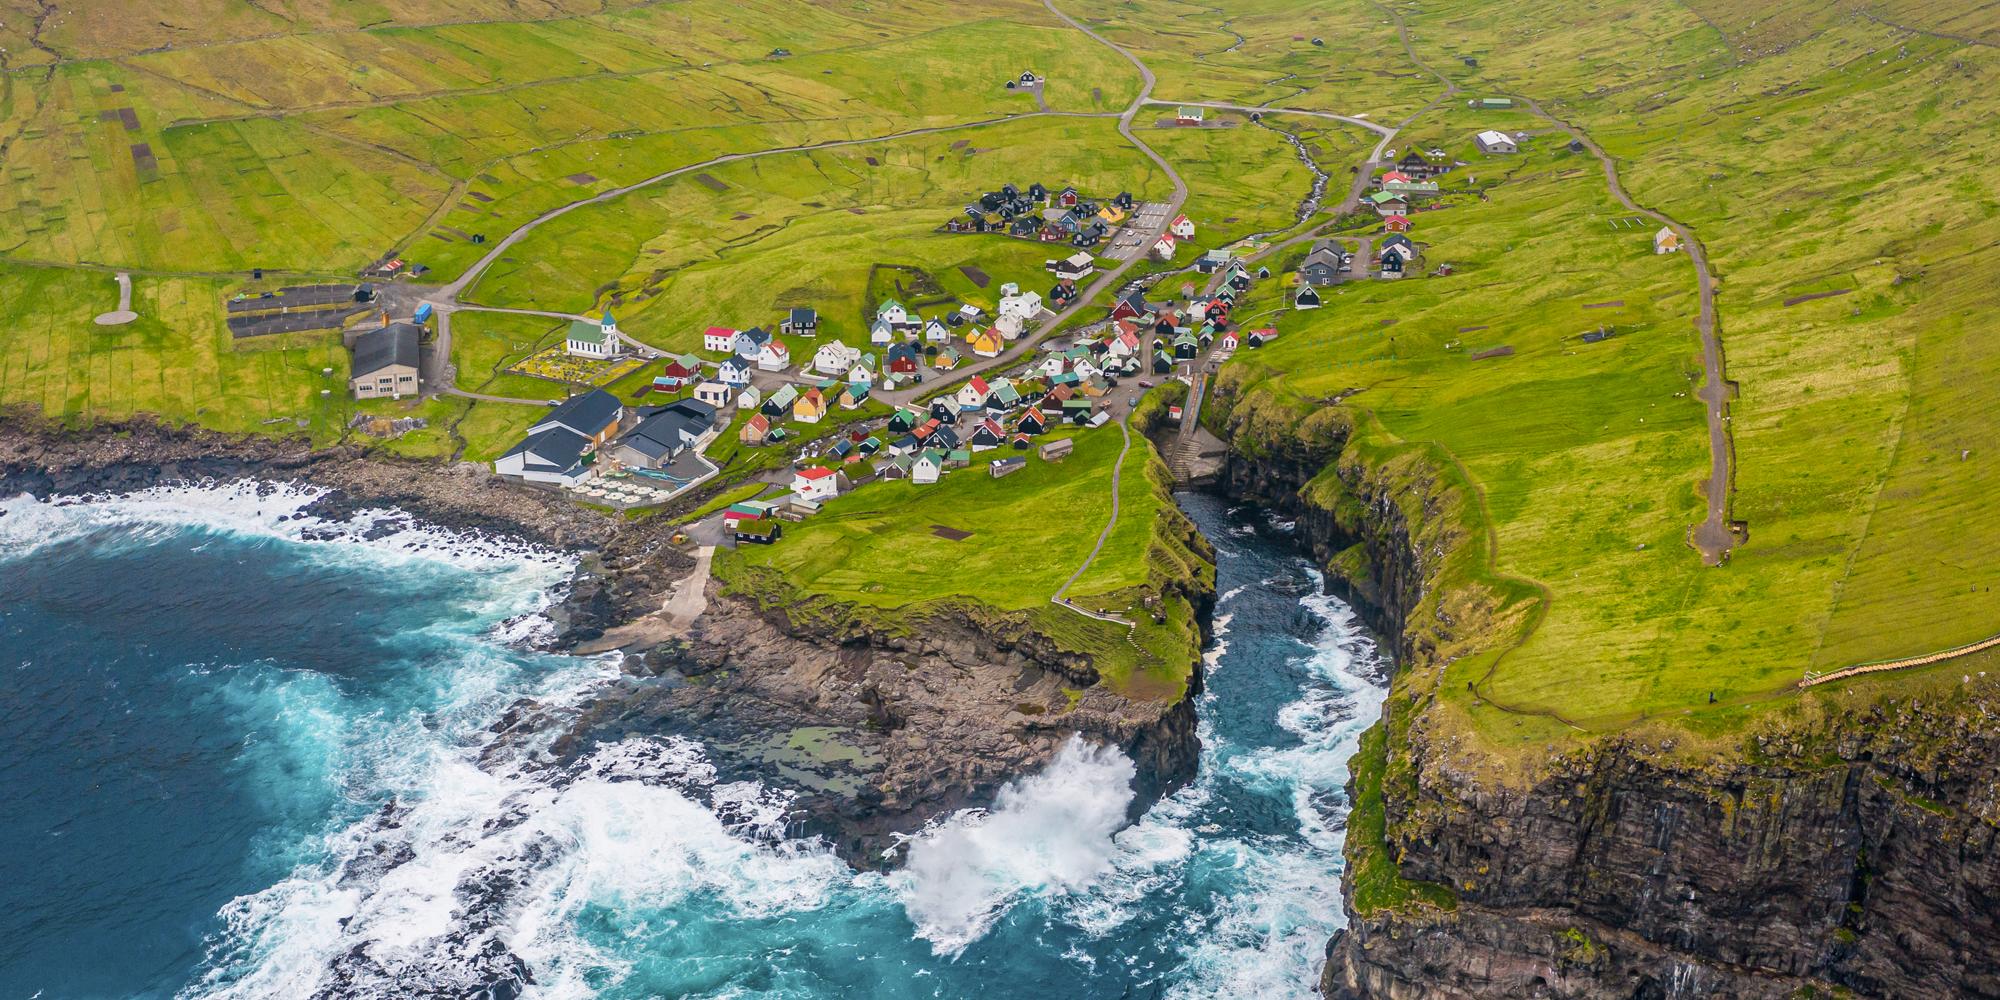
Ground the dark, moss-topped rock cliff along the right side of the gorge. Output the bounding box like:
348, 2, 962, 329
1214, 388, 2000, 1000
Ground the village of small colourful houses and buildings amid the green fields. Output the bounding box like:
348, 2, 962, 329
328, 120, 1608, 544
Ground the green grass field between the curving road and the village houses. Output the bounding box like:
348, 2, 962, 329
470, 120, 1168, 350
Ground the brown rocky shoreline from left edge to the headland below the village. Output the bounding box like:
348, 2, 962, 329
0, 418, 1214, 866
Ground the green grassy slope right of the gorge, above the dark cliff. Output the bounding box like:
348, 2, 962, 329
1184, 4, 2000, 744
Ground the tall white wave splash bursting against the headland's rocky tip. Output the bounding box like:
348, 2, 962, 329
894, 736, 1138, 954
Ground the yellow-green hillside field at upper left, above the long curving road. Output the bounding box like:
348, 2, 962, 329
0, 0, 1136, 276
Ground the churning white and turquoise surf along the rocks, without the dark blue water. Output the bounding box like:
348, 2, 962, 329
11, 484, 1382, 1000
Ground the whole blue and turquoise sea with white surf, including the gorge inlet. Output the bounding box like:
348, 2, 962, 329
0, 484, 1386, 1000
